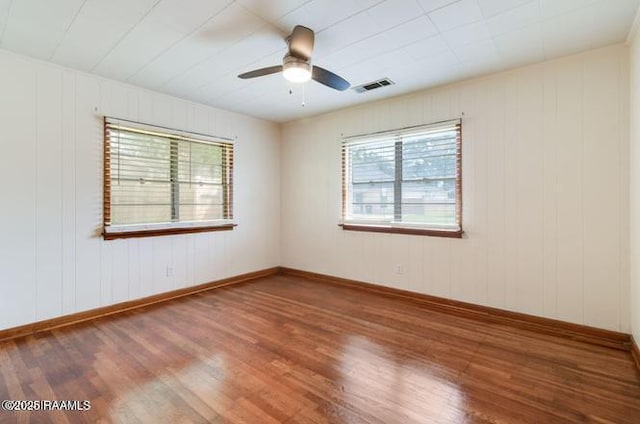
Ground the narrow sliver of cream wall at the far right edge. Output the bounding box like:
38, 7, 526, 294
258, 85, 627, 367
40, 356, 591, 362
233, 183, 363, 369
629, 22, 640, 343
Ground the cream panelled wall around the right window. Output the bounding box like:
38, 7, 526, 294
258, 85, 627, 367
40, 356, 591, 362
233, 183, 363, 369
281, 46, 630, 332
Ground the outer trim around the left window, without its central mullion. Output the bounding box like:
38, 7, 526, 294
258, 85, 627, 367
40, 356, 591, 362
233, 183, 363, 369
102, 116, 238, 240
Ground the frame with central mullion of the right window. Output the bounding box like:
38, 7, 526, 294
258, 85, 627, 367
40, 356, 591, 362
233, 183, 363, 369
338, 119, 464, 238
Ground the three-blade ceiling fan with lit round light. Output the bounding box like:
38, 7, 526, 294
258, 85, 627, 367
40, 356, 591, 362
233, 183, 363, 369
238, 25, 350, 91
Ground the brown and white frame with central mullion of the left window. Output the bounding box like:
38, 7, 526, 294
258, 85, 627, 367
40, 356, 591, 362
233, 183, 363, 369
102, 116, 237, 240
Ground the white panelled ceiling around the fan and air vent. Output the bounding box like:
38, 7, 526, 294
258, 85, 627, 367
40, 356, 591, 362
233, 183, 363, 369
0, 0, 640, 122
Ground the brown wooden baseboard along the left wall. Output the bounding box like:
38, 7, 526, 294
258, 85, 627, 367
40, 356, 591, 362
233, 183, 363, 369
0, 267, 280, 342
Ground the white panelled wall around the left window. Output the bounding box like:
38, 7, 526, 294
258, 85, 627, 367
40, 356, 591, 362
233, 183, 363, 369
0, 50, 280, 329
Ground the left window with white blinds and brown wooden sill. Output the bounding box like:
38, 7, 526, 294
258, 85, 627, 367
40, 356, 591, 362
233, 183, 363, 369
104, 118, 234, 239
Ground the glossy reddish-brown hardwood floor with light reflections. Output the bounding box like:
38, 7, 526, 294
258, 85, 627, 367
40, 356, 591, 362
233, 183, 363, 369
0, 275, 640, 423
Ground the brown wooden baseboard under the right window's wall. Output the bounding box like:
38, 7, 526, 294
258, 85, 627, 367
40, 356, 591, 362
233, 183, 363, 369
280, 267, 640, 352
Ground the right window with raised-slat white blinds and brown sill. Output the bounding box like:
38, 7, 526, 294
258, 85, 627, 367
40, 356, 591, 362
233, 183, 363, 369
341, 120, 462, 237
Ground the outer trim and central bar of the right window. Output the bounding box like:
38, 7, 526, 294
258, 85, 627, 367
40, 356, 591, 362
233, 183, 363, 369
338, 118, 464, 238
